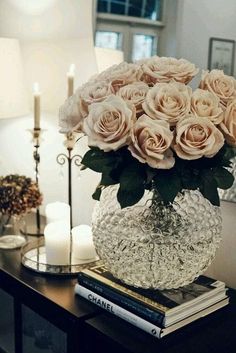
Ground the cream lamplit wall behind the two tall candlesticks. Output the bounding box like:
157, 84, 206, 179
0, 0, 98, 224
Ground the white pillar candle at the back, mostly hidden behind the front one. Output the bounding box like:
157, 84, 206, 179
45, 201, 70, 224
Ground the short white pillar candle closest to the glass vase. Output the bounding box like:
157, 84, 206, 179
72, 225, 97, 263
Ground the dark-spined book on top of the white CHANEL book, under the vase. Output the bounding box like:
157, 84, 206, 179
78, 265, 228, 327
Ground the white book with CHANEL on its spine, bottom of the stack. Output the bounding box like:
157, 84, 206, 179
75, 283, 229, 338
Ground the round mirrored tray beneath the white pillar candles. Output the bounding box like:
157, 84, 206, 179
21, 237, 101, 276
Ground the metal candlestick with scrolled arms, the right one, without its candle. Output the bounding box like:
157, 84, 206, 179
56, 133, 83, 228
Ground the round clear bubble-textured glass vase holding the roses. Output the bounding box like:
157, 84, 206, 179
92, 185, 222, 289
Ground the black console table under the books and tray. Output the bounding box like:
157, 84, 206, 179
0, 241, 236, 353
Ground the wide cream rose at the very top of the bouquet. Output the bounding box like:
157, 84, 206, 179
140, 56, 199, 85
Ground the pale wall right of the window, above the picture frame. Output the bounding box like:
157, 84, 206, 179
176, 0, 236, 73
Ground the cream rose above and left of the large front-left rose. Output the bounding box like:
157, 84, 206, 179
80, 81, 114, 117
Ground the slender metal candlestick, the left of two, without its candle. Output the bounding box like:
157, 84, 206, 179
21, 128, 46, 236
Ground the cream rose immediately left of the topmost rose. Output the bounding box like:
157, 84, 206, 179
97, 62, 141, 92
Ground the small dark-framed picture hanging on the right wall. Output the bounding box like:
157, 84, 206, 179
208, 37, 235, 76
